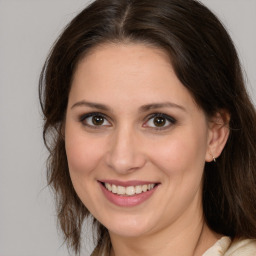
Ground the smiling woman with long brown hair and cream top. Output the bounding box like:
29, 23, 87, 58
40, 0, 256, 256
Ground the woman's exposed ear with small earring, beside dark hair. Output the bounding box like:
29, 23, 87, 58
205, 110, 230, 162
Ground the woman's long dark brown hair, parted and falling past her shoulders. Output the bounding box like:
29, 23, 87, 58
39, 0, 256, 255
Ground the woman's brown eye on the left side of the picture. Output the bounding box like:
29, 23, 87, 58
80, 113, 111, 128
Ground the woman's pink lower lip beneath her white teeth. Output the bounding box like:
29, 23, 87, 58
100, 183, 158, 207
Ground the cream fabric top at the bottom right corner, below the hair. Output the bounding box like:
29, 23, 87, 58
202, 236, 256, 256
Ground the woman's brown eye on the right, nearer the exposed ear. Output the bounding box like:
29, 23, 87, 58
143, 113, 176, 129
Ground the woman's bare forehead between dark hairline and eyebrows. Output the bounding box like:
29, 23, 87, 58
70, 43, 197, 112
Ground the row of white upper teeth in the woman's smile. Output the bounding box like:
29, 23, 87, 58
104, 183, 155, 196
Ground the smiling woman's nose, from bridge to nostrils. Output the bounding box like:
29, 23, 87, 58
106, 127, 146, 174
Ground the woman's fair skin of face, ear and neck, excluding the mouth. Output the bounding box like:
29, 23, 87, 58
65, 43, 228, 256
